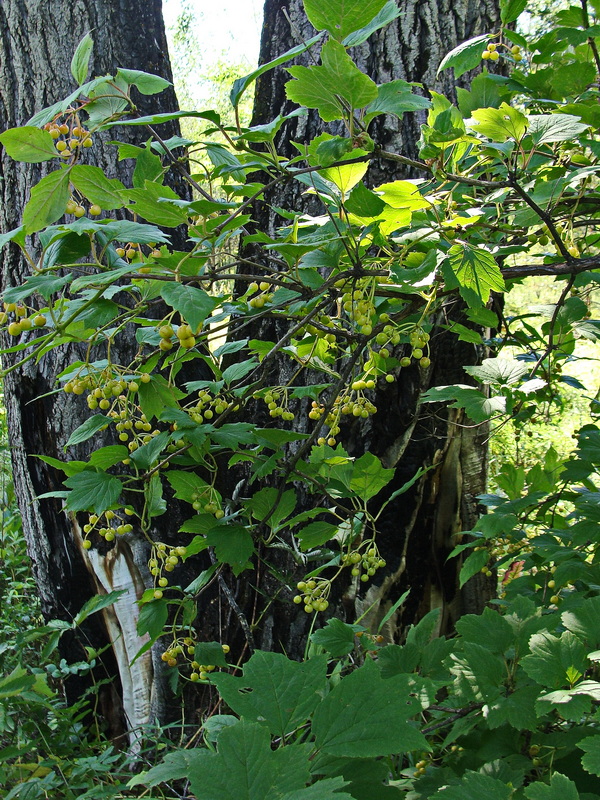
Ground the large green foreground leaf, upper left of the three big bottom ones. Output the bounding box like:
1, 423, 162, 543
213, 650, 327, 737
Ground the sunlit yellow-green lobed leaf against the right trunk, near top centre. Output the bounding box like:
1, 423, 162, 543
285, 40, 377, 122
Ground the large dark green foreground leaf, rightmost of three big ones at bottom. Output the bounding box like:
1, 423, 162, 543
312, 660, 430, 758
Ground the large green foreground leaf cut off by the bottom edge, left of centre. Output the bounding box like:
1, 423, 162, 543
184, 720, 310, 800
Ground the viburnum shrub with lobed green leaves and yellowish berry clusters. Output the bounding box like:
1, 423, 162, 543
0, 0, 600, 800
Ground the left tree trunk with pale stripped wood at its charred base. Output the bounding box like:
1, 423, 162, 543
0, 0, 185, 733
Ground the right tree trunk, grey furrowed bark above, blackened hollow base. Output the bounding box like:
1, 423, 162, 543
221, 0, 499, 657
